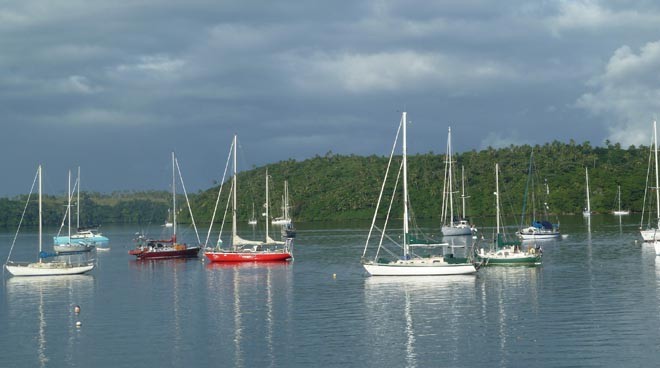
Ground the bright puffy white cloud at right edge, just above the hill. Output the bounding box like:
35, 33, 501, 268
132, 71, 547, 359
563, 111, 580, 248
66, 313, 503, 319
576, 41, 660, 146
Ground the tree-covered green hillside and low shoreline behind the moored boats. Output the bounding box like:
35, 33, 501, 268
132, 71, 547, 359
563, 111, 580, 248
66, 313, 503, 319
0, 141, 649, 227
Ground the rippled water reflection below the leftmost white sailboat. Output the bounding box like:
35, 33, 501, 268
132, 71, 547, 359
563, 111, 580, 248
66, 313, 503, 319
3, 275, 94, 367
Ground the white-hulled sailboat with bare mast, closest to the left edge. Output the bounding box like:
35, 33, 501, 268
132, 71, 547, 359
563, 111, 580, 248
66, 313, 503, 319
5, 165, 94, 276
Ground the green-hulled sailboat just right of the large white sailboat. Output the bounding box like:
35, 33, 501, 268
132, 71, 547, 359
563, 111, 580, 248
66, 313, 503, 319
476, 164, 543, 266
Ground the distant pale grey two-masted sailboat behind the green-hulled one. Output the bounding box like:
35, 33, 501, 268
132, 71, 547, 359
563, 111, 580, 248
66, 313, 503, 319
440, 127, 474, 236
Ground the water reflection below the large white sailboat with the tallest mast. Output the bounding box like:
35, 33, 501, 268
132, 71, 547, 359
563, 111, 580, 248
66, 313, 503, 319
364, 275, 477, 367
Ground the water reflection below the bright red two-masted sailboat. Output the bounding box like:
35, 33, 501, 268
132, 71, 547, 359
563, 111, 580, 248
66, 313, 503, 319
205, 261, 295, 367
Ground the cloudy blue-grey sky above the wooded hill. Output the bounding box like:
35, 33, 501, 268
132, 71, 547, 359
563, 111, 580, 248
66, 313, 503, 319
0, 0, 660, 196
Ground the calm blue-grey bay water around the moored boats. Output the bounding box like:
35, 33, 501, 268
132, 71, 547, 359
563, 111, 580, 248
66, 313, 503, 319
0, 215, 660, 367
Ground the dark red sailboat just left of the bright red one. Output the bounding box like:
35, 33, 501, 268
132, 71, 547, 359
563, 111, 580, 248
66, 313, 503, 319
128, 152, 201, 259
